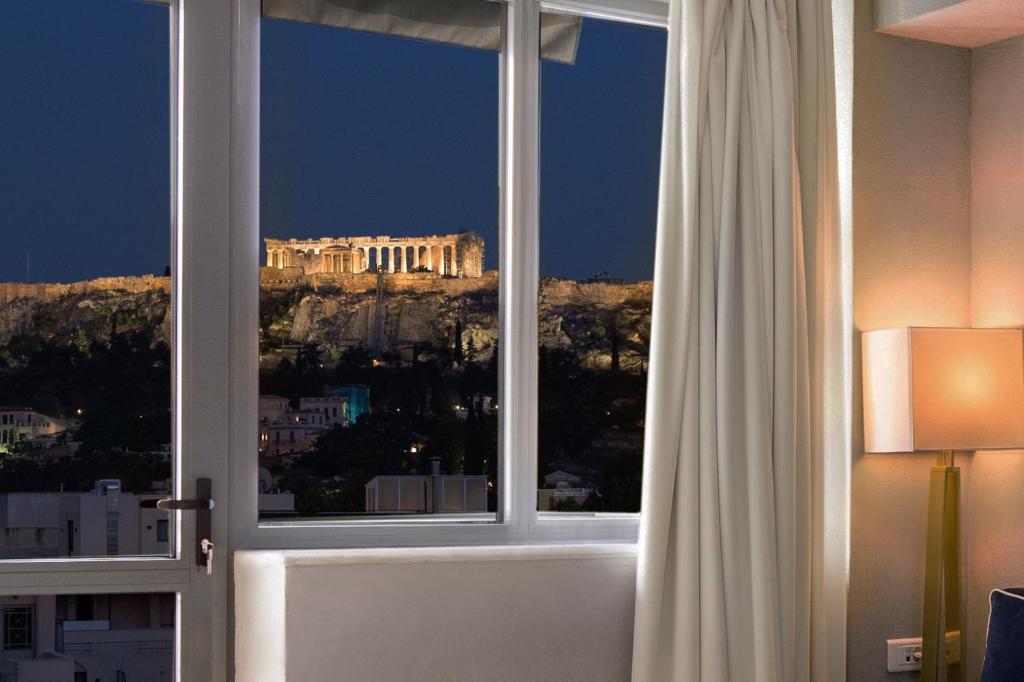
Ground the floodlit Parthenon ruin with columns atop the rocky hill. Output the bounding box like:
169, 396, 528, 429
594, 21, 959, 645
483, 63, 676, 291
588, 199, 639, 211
263, 232, 483, 278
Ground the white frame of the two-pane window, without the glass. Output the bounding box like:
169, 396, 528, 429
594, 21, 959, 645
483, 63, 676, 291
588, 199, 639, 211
227, 0, 668, 550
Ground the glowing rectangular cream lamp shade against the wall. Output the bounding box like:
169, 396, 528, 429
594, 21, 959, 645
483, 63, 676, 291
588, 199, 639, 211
861, 327, 1024, 453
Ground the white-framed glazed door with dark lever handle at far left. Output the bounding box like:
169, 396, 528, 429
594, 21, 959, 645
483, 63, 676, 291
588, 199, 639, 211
0, 0, 231, 680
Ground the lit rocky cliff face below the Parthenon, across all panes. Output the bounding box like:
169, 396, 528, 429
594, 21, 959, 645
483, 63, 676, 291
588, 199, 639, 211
0, 268, 651, 371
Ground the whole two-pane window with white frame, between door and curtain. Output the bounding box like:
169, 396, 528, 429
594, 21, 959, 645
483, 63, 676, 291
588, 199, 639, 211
231, 0, 666, 548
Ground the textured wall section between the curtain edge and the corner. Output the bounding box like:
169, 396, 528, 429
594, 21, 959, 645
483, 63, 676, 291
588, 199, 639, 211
847, 0, 971, 682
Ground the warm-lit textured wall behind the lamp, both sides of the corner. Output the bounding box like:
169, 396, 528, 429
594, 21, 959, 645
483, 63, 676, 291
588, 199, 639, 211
848, 9, 1024, 682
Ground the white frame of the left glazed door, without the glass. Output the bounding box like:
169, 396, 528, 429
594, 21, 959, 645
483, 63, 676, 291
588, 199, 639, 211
0, 0, 232, 682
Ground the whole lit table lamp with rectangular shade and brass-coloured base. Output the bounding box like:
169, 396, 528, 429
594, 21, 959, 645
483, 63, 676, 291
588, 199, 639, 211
861, 327, 1024, 680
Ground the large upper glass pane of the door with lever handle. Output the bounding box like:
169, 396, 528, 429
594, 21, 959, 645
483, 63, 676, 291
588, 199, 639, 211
0, 0, 172, 559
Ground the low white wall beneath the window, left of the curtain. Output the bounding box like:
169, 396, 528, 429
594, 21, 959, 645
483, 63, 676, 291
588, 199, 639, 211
234, 545, 636, 682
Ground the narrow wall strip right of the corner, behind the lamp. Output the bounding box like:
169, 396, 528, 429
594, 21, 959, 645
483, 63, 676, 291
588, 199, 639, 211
964, 38, 1024, 679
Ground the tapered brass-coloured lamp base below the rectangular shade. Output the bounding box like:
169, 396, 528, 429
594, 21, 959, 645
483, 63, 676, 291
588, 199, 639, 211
921, 451, 962, 682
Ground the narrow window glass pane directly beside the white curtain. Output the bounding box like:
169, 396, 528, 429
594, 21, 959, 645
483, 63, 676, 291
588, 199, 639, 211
538, 15, 666, 512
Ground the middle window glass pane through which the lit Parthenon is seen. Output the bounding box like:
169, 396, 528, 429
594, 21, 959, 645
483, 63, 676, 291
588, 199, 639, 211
259, 3, 500, 519
